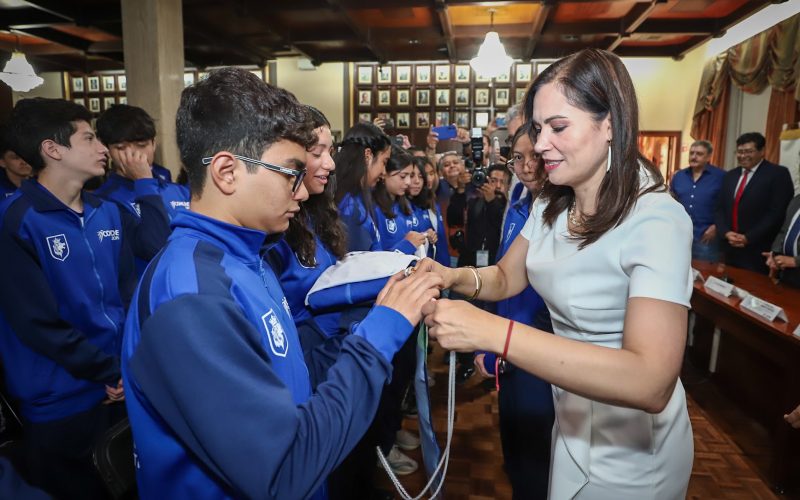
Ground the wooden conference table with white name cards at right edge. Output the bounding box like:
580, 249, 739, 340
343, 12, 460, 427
687, 261, 800, 491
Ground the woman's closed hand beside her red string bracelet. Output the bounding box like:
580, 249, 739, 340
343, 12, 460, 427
422, 299, 508, 352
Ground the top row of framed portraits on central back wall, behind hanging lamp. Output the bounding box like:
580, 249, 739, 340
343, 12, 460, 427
356, 61, 550, 85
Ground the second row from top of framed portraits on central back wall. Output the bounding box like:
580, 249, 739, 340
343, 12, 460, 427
358, 87, 527, 108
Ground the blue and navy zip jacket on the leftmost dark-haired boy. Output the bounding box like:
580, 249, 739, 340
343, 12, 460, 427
0, 181, 169, 422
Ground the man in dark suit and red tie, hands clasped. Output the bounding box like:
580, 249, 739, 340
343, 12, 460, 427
716, 132, 794, 274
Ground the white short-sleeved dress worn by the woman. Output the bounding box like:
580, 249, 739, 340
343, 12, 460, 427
521, 177, 694, 500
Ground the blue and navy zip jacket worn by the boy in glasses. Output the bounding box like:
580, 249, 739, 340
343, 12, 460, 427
122, 211, 412, 499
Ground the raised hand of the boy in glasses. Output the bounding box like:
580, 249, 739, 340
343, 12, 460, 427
375, 268, 443, 325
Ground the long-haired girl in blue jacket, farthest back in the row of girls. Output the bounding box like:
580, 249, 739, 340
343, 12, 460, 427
407, 156, 450, 266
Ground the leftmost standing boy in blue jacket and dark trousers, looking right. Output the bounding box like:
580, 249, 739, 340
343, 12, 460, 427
0, 98, 169, 498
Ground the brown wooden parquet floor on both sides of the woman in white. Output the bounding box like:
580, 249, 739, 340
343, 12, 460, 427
376, 346, 791, 500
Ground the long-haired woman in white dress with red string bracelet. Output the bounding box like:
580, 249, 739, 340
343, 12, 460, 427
417, 49, 693, 500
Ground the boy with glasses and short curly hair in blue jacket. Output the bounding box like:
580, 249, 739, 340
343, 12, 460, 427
122, 68, 441, 499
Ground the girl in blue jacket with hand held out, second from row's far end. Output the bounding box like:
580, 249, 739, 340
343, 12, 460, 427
372, 146, 427, 255
